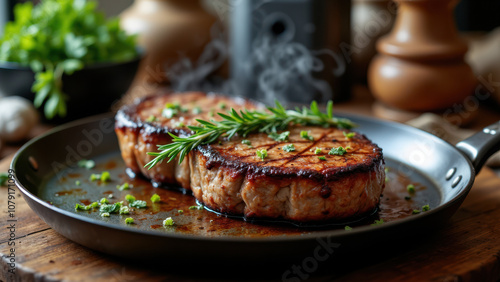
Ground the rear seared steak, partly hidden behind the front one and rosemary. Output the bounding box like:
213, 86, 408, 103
115, 92, 257, 189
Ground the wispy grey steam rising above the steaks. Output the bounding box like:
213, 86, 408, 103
167, 5, 346, 104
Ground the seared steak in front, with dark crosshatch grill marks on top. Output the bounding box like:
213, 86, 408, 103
189, 127, 385, 222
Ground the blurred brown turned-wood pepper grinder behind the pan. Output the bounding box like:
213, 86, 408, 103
368, 0, 476, 123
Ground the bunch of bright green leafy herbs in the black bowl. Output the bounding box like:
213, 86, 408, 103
0, 0, 137, 119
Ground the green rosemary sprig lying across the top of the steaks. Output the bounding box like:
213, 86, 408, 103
145, 101, 355, 169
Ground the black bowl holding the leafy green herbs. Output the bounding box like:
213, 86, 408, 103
0, 57, 141, 123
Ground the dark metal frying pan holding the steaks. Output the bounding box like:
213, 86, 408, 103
11, 114, 500, 261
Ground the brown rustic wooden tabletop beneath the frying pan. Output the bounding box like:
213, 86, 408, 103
0, 87, 500, 281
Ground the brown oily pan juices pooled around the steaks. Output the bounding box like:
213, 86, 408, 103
38, 152, 440, 237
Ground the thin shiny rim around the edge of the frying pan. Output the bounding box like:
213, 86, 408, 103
10, 111, 475, 243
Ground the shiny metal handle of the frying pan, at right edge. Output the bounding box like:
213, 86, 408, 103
456, 121, 500, 174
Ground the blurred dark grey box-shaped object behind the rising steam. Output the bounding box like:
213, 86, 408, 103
229, 0, 351, 103
